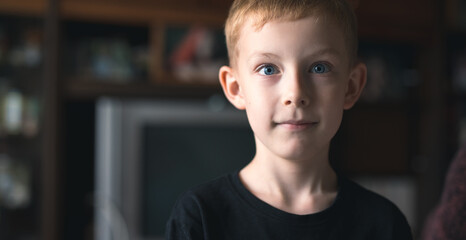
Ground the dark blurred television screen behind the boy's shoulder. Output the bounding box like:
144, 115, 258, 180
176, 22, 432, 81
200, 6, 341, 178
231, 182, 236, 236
141, 123, 254, 237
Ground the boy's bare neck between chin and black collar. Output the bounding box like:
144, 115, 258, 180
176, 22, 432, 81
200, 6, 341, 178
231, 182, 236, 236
240, 142, 338, 214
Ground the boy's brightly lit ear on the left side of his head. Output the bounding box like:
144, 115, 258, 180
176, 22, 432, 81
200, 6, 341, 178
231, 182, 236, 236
218, 66, 246, 110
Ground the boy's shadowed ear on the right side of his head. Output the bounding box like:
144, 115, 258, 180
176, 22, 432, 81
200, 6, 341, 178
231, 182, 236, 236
343, 63, 367, 110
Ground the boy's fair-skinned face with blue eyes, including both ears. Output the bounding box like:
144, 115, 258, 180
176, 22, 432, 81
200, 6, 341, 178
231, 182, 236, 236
220, 17, 365, 163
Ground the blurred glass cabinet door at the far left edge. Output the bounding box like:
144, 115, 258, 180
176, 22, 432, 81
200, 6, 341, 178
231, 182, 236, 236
0, 15, 43, 240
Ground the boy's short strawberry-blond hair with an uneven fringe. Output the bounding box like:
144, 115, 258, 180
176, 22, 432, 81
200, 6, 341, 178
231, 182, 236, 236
225, 0, 358, 64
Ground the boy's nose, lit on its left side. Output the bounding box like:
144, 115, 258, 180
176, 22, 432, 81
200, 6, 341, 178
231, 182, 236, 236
282, 72, 310, 107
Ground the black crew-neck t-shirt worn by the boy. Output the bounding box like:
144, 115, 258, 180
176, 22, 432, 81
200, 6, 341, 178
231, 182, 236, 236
166, 173, 412, 240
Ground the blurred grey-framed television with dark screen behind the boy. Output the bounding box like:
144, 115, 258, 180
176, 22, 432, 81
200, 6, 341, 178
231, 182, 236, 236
94, 95, 255, 240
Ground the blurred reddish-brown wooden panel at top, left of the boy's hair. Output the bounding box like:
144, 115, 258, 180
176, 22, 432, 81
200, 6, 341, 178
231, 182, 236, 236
60, 0, 229, 23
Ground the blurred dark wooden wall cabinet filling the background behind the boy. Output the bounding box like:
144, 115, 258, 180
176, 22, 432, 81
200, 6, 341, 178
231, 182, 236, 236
0, 0, 458, 240
